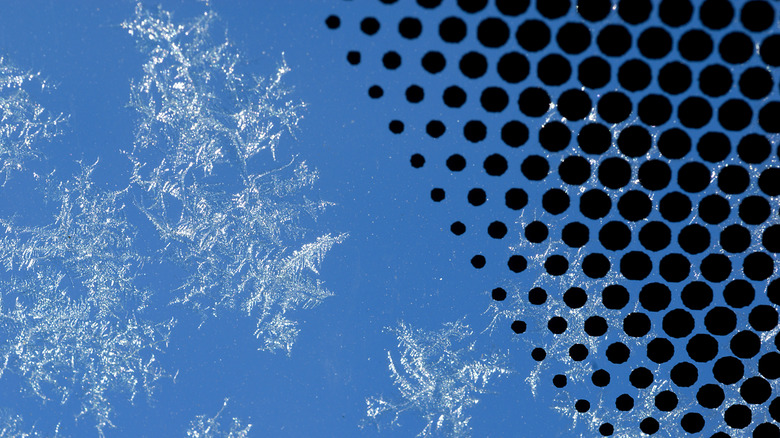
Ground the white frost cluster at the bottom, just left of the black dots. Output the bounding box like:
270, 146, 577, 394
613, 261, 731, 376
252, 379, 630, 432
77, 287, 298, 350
366, 321, 510, 437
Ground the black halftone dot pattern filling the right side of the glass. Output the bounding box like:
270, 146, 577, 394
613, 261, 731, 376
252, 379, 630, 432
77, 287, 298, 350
325, 0, 780, 438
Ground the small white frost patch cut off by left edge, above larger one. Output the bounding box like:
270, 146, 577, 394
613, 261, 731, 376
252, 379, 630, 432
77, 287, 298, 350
0, 57, 65, 184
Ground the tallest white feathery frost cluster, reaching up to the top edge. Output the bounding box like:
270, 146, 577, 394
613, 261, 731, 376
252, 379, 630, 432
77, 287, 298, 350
123, 5, 346, 354
